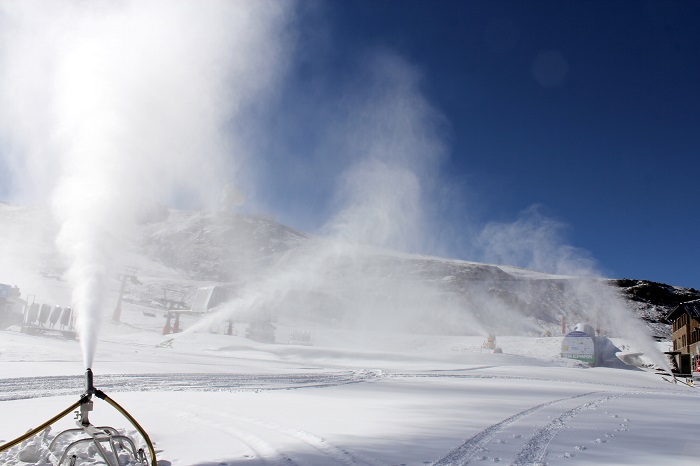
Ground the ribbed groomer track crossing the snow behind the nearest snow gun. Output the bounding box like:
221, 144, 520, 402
0, 371, 382, 401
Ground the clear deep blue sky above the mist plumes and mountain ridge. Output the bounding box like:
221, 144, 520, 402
258, 0, 700, 287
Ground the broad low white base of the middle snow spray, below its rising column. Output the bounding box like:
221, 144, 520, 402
172, 238, 486, 339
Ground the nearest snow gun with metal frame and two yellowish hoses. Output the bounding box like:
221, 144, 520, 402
0, 368, 158, 466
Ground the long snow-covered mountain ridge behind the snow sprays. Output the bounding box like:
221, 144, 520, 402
0, 205, 700, 337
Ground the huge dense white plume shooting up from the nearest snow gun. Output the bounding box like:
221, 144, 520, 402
0, 0, 289, 366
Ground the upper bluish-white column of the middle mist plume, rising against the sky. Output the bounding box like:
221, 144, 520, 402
324, 50, 446, 251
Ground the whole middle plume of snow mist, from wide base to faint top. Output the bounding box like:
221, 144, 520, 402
180, 51, 468, 342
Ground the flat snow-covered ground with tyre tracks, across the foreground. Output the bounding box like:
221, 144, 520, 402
0, 308, 700, 466
